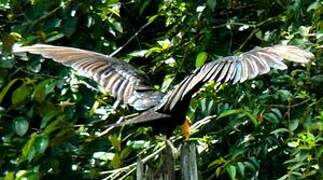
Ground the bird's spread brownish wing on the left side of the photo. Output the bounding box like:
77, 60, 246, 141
13, 44, 163, 110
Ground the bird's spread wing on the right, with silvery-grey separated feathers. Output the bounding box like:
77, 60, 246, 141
158, 45, 314, 111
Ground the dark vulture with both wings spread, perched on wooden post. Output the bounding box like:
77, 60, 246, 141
13, 44, 314, 138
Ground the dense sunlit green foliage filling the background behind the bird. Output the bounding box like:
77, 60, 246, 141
0, 0, 323, 180
